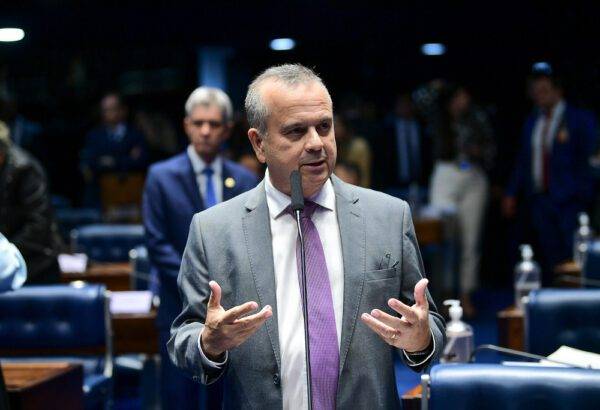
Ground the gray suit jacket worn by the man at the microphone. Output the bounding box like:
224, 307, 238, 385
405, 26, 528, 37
168, 176, 445, 409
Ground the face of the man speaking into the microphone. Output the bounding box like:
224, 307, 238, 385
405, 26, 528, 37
248, 80, 337, 197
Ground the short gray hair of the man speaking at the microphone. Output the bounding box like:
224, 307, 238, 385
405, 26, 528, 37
245, 64, 331, 136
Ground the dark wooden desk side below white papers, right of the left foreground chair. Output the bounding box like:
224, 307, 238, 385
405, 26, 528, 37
112, 310, 158, 355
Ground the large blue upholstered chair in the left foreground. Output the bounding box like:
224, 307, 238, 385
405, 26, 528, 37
0, 285, 113, 409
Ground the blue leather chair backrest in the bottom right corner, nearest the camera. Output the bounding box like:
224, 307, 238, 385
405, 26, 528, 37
423, 364, 600, 410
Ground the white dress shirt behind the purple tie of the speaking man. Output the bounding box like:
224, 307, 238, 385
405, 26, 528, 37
265, 170, 344, 409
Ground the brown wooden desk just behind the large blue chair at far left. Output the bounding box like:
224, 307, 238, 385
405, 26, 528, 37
61, 262, 132, 290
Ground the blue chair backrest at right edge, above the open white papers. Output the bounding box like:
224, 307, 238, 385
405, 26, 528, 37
525, 289, 600, 356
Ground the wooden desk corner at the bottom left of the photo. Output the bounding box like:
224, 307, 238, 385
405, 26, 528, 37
1, 363, 83, 410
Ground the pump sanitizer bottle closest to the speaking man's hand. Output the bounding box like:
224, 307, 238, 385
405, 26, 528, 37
441, 299, 473, 363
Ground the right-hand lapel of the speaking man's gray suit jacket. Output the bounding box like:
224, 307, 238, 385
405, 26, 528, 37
331, 175, 366, 374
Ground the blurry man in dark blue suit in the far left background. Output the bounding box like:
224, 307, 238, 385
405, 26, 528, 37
80, 93, 148, 206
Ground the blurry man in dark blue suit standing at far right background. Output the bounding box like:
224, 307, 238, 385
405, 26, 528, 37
503, 72, 596, 285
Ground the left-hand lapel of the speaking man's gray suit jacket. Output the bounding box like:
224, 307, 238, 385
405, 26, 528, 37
243, 180, 281, 369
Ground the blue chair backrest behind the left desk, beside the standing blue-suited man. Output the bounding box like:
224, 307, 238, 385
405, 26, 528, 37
71, 225, 144, 262
